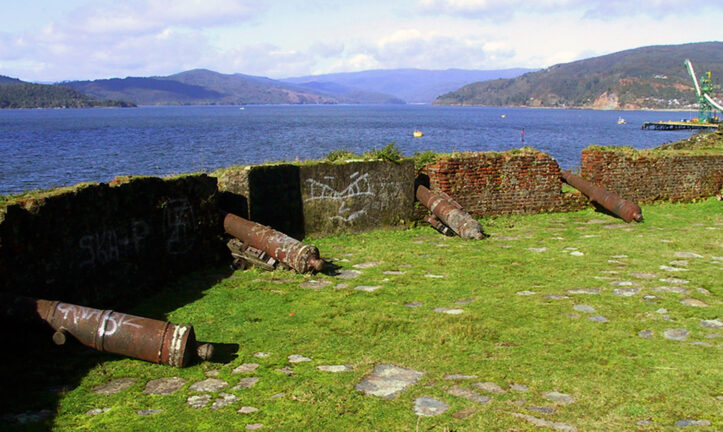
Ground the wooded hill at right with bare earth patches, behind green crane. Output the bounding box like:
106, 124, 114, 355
434, 42, 723, 109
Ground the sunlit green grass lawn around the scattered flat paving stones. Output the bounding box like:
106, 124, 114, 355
5, 199, 723, 431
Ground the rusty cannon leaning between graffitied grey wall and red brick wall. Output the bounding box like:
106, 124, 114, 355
416, 185, 487, 240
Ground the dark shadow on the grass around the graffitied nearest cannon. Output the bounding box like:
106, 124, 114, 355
0, 266, 233, 431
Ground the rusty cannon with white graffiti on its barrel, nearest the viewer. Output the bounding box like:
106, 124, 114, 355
13, 296, 213, 367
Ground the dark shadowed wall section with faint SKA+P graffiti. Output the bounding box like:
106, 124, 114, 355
0, 175, 227, 307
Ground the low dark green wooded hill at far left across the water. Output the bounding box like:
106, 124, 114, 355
0, 76, 134, 108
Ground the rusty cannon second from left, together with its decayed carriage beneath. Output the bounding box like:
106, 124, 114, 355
223, 213, 324, 273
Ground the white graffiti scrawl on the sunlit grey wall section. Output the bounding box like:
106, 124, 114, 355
305, 172, 374, 223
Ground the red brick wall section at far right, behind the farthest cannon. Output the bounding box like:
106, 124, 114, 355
580, 147, 723, 203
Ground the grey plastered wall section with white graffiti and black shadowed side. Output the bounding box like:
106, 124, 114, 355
214, 161, 414, 239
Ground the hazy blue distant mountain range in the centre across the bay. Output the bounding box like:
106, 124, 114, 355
60, 69, 529, 105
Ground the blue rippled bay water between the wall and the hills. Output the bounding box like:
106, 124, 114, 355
0, 105, 695, 195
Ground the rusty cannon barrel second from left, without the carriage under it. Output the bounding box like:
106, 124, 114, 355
223, 213, 325, 273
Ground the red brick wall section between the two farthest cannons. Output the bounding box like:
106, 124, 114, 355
425, 148, 585, 216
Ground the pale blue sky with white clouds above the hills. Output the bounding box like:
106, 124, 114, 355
0, 0, 723, 82
